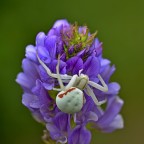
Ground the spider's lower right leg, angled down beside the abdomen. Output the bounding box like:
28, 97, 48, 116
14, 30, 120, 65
85, 85, 106, 106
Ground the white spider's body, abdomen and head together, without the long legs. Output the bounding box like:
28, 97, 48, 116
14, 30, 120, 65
54, 74, 88, 114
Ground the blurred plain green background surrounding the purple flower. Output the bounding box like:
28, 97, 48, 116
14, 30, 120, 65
0, 0, 144, 144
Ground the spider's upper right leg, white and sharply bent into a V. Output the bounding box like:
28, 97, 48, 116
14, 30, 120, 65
88, 74, 108, 92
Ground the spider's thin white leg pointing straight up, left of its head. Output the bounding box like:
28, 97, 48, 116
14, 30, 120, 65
56, 55, 65, 90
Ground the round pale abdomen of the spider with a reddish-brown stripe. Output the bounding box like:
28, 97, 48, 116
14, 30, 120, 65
56, 87, 84, 114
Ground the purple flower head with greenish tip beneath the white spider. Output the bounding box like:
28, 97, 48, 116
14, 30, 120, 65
16, 20, 123, 144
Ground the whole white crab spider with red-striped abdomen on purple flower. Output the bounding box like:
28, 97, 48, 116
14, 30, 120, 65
37, 55, 108, 114
